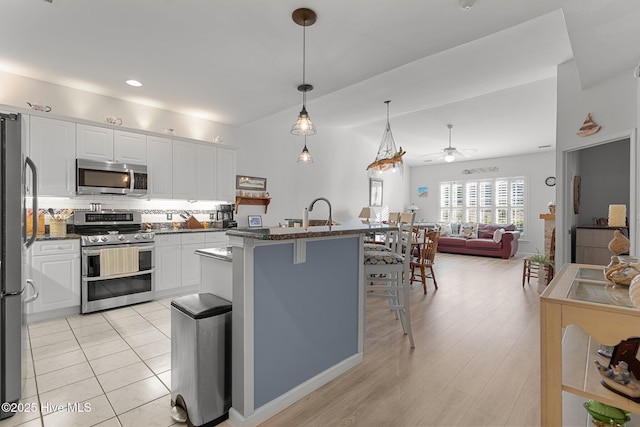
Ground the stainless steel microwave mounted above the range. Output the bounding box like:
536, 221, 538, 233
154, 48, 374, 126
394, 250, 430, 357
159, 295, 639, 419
76, 159, 148, 196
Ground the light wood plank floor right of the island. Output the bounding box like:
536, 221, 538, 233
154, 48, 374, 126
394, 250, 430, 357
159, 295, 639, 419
261, 253, 540, 427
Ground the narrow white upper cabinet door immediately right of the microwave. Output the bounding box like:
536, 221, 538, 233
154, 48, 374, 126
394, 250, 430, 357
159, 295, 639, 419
147, 136, 173, 199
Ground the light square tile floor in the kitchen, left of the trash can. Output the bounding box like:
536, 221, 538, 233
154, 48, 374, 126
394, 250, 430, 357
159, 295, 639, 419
0, 299, 186, 427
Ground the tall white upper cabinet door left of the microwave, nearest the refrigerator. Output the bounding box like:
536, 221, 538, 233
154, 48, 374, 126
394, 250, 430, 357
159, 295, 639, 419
29, 116, 76, 197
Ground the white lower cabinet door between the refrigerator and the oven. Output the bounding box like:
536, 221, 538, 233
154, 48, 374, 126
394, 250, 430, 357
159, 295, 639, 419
31, 251, 80, 313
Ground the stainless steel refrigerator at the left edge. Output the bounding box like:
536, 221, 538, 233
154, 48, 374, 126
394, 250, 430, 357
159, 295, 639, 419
0, 113, 38, 419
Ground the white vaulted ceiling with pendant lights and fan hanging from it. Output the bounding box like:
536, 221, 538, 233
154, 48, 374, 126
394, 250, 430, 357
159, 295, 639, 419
0, 0, 640, 165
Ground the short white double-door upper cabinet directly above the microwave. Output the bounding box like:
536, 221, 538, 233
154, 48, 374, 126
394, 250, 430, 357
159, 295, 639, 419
76, 124, 147, 165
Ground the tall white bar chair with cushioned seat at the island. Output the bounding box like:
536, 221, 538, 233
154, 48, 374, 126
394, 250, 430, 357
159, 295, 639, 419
364, 213, 415, 347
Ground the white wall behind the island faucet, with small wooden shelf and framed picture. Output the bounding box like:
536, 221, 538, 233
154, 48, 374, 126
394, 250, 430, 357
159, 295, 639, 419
237, 126, 409, 226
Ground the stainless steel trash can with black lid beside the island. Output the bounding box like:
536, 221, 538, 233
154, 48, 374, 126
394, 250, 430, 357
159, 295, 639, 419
171, 293, 231, 426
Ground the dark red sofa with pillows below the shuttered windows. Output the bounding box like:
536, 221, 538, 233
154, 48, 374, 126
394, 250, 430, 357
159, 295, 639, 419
438, 223, 520, 259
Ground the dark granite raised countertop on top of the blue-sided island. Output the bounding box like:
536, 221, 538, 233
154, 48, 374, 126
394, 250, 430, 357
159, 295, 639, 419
227, 221, 398, 240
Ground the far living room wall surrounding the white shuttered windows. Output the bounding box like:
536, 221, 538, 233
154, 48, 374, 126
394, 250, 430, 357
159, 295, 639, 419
410, 151, 555, 254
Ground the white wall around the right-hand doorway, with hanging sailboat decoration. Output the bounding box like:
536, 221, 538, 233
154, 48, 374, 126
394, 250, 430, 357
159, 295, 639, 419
556, 60, 639, 265
